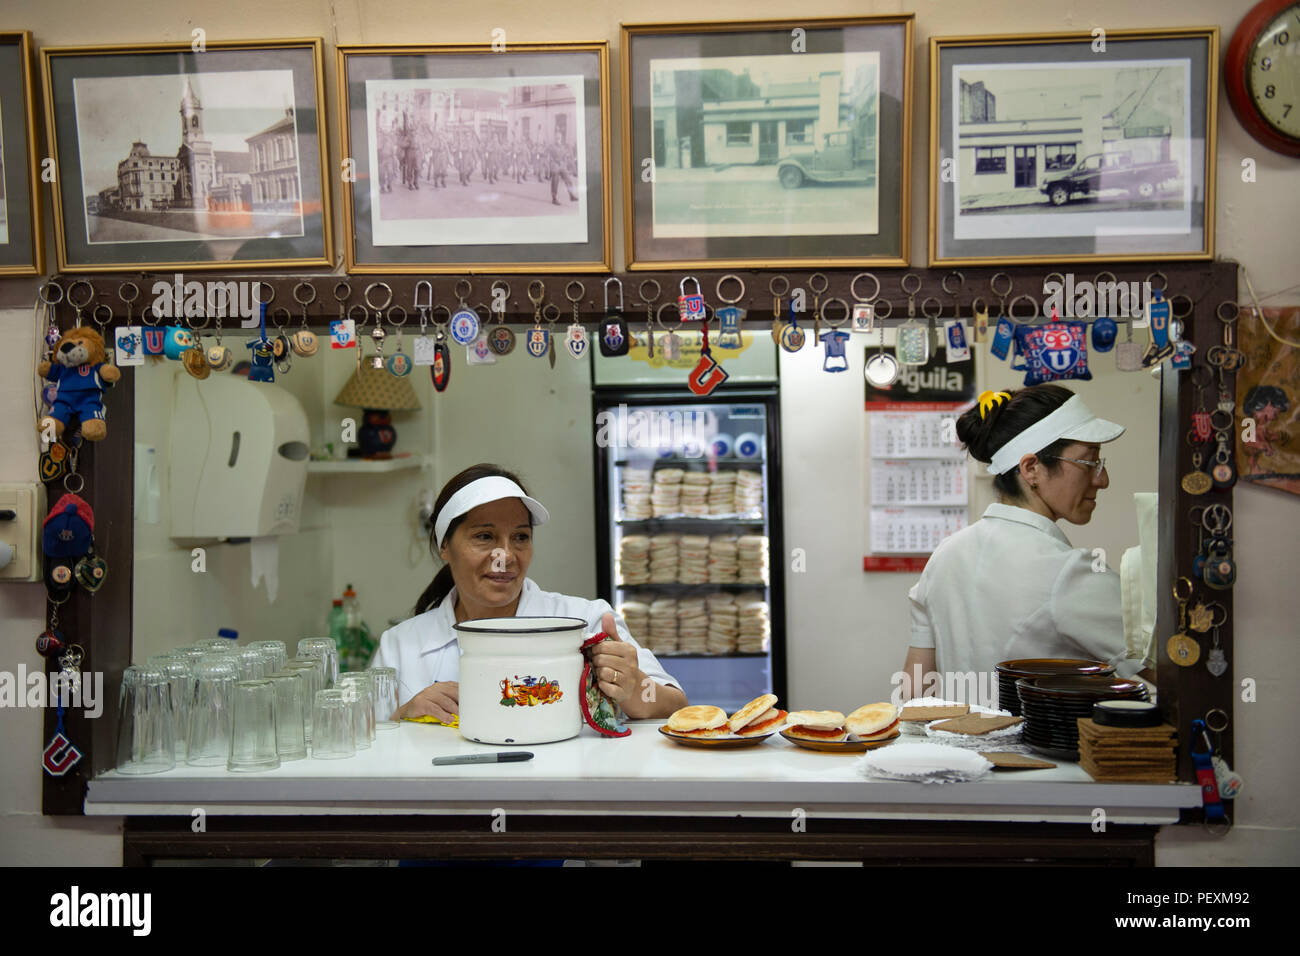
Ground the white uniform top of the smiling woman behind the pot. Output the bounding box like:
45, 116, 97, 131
371, 578, 681, 706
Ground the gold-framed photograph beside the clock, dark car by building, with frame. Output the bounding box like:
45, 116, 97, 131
930, 27, 1218, 265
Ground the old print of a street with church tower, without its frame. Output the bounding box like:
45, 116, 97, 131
73, 70, 303, 243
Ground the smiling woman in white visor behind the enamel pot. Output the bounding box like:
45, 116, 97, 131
372, 464, 686, 721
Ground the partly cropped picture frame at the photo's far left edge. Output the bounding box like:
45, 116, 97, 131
0, 31, 46, 276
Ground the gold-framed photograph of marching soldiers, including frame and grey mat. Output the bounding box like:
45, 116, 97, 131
338, 40, 614, 273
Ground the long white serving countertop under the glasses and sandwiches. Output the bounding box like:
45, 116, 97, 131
86, 721, 1201, 825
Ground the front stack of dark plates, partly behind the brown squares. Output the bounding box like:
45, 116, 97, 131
1015, 675, 1147, 760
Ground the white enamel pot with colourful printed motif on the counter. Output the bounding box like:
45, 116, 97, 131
455, 618, 588, 744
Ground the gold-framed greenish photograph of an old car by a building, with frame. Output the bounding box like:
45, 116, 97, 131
621, 14, 913, 269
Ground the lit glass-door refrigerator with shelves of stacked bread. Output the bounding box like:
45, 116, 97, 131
592, 333, 785, 713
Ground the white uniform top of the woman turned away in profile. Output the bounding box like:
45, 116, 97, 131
907, 502, 1144, 692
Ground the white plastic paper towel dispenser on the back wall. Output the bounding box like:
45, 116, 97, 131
168, 369, 308, 538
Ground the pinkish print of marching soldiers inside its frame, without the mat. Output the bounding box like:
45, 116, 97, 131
367, 77, 586, 246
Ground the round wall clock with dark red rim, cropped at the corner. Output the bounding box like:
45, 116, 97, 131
1223, 0, 1300, 157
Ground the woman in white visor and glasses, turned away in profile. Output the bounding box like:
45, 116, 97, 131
902, 384, 1153, 702
